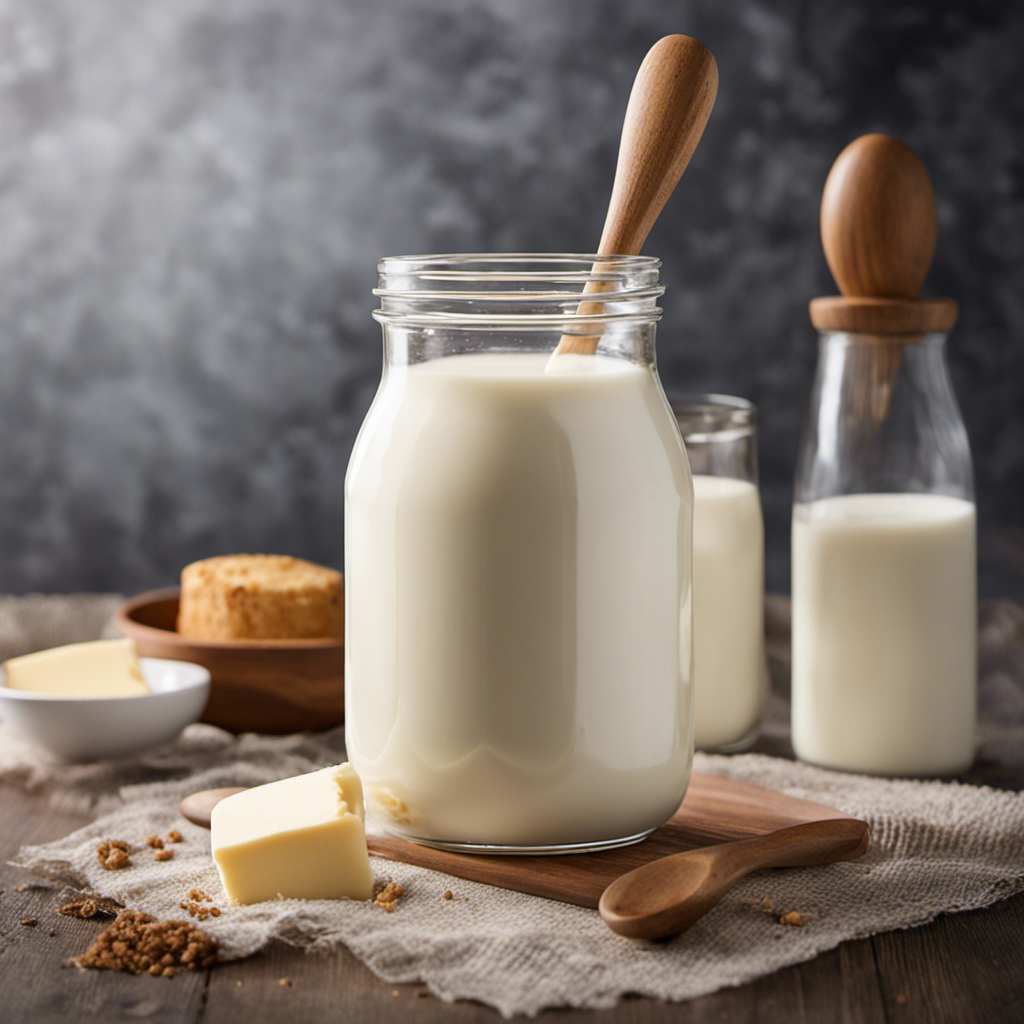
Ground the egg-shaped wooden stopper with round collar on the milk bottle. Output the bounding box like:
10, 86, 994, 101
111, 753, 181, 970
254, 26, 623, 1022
811, 133, 956, 335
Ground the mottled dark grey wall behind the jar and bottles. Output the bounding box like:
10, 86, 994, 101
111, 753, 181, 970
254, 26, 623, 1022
0, 0, 1024, 592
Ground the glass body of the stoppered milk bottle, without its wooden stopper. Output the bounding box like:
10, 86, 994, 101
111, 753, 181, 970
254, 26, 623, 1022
793, 331, 977, 775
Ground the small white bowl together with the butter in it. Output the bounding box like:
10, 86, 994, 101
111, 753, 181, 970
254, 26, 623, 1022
0, 640, 210, 761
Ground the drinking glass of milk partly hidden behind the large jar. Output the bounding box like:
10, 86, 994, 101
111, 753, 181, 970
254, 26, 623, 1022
672, 394, 767, 751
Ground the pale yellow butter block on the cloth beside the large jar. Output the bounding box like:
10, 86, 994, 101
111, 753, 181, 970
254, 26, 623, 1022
210, 763, 374, 903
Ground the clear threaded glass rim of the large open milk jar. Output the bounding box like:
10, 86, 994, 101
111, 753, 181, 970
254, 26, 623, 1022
373, 253, 665, 331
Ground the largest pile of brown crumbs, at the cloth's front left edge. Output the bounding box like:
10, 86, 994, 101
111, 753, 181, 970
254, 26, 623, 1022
70, 910, 217, 978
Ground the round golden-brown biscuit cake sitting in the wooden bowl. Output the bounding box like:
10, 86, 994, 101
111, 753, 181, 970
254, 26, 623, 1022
177, 555, 344, 641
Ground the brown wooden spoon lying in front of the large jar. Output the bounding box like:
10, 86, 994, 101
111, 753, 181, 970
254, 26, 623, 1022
598, 818, 867, 939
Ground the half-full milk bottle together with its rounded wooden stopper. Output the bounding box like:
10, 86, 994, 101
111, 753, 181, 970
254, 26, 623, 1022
793, 135, 977, 775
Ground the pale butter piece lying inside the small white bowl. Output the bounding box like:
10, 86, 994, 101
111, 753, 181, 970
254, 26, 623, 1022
4, 640, 150, 697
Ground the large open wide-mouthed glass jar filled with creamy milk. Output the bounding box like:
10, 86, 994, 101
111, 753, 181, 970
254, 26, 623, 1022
345, 255, 692, 853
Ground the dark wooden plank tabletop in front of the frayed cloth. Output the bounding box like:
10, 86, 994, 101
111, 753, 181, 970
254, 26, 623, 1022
0, 779, 1024, 1024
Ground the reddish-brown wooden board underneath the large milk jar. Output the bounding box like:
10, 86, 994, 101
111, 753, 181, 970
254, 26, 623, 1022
367, 774, 868, 907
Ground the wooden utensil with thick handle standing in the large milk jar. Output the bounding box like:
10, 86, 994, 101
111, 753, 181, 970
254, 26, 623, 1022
555, 36, 718, 355
